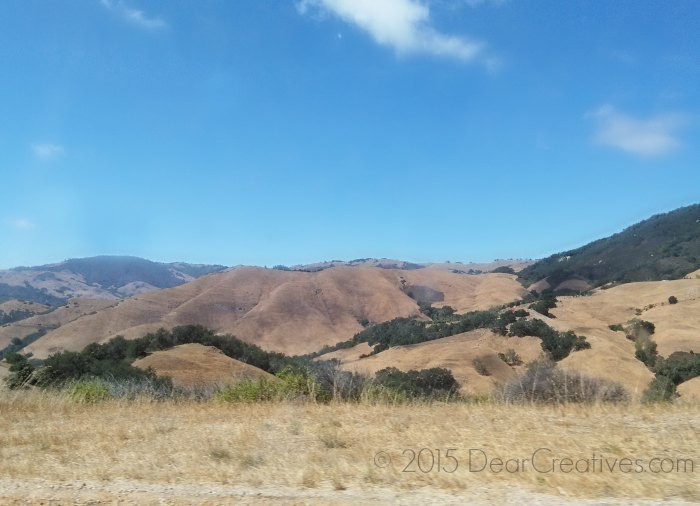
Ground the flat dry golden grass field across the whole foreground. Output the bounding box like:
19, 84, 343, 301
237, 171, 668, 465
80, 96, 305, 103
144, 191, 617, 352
0, 391, 700, 504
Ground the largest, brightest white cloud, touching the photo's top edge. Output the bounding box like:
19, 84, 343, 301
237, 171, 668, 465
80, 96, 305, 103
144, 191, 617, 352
297, 0, 490, 62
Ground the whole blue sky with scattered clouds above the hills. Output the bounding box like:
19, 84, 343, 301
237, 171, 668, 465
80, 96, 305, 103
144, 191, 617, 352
0, 0, 700, 267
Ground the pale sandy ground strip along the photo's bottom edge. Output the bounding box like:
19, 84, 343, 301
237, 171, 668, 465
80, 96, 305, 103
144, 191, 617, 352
0, 478, 697, 506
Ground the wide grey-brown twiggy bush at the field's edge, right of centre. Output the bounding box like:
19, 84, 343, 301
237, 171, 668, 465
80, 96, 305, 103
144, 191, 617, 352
497, 359, 629, 404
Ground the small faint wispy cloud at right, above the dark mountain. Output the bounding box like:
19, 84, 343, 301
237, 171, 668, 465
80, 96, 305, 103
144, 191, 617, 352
589, 105, 687, 156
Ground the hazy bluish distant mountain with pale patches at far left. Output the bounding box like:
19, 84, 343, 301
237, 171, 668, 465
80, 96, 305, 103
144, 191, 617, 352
0, 256, 226, 306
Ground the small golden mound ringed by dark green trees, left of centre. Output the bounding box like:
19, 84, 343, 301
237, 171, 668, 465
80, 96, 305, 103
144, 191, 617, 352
133, 343, 274, 387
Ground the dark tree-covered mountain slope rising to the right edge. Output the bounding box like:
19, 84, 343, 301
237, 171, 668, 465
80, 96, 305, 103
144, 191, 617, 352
519, 204, 700, 292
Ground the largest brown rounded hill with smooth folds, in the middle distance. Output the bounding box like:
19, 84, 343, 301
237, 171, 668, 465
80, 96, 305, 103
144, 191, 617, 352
20, 267, 525, 358
